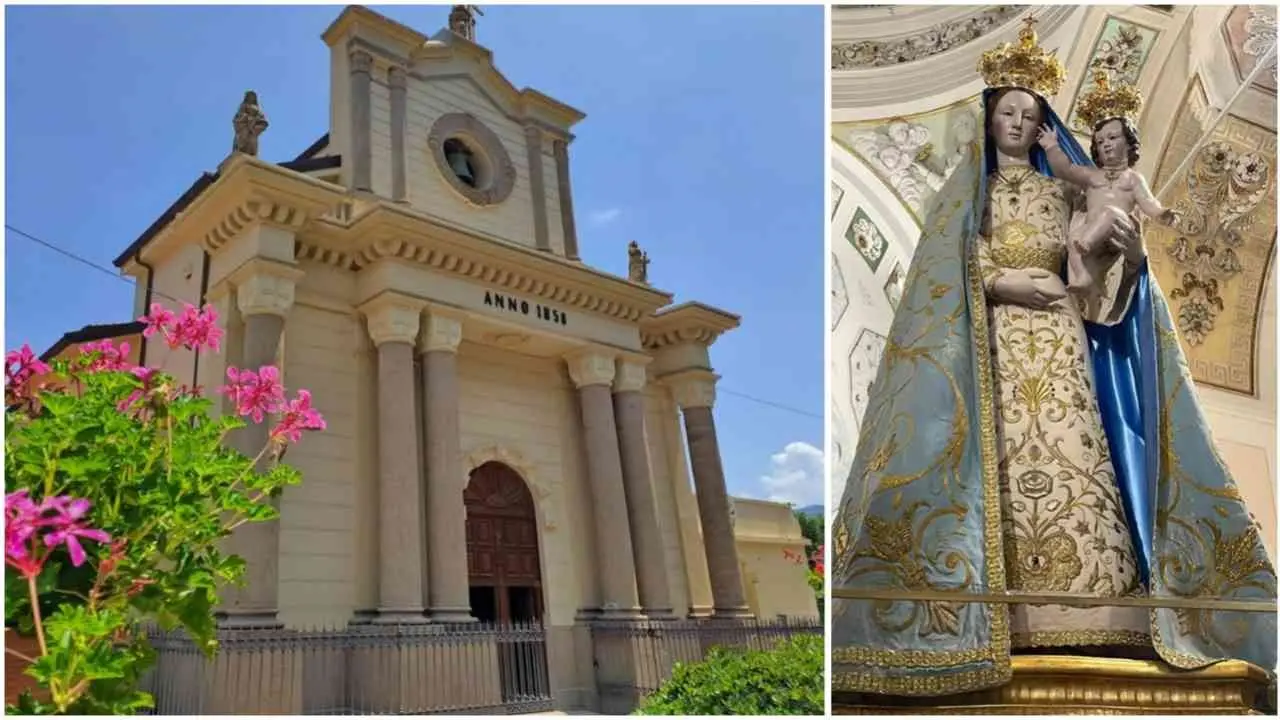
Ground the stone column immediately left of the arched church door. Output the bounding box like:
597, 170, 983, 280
421, 310, 475, 623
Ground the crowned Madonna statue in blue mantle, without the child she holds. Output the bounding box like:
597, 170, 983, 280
832, 19, 1276, 696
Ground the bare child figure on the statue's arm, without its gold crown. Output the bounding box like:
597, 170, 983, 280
1039, 118, 1174, 293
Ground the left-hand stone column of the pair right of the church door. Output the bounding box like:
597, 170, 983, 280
567, 352, 640, 618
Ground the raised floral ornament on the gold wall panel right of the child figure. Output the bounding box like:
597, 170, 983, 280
1165, 141, 1272, 346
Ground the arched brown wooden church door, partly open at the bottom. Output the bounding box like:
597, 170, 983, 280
462, 461, 543, 623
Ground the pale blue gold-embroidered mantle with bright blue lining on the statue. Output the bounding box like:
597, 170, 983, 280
832, 91, 1276, 696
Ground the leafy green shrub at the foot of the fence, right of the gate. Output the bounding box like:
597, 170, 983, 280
635, 634, 824, 715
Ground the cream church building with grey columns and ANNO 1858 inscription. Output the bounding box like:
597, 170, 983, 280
42, 6, 820, 712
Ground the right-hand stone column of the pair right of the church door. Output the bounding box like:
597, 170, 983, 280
613, 359, 671, 618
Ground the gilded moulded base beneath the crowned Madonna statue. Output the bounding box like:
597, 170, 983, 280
832, 655, 1276, 715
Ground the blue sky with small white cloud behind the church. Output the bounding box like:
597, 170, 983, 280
5, 5, 827, 505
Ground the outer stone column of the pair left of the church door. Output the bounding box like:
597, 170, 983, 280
361, 295, 426, 623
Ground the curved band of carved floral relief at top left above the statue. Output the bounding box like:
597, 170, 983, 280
831, 5, 1021, 70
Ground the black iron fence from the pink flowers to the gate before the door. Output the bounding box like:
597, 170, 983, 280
143, 623, 552, 715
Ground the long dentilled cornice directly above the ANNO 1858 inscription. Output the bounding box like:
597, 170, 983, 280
297, 200, 671, 322
